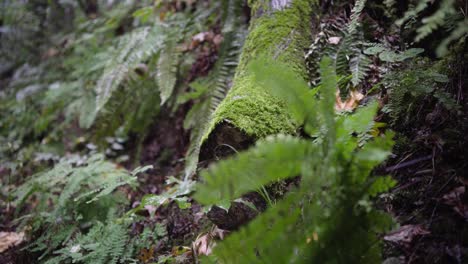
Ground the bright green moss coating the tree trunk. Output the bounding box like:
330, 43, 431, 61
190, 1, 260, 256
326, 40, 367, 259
202, 0, 312, 141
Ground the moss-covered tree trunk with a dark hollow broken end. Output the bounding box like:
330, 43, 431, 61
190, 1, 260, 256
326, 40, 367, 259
201, 0, 313, 229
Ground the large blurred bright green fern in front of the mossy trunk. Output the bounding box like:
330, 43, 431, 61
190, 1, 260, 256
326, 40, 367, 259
195, 58, 394, 263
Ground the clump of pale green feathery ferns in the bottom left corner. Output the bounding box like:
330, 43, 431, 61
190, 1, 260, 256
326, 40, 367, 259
13, 155, 152, 263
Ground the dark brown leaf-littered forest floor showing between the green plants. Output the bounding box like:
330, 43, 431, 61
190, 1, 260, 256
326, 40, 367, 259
0, 1, 468, 264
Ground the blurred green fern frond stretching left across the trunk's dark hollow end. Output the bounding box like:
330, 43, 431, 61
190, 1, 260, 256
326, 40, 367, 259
195, 135, 312, 204
